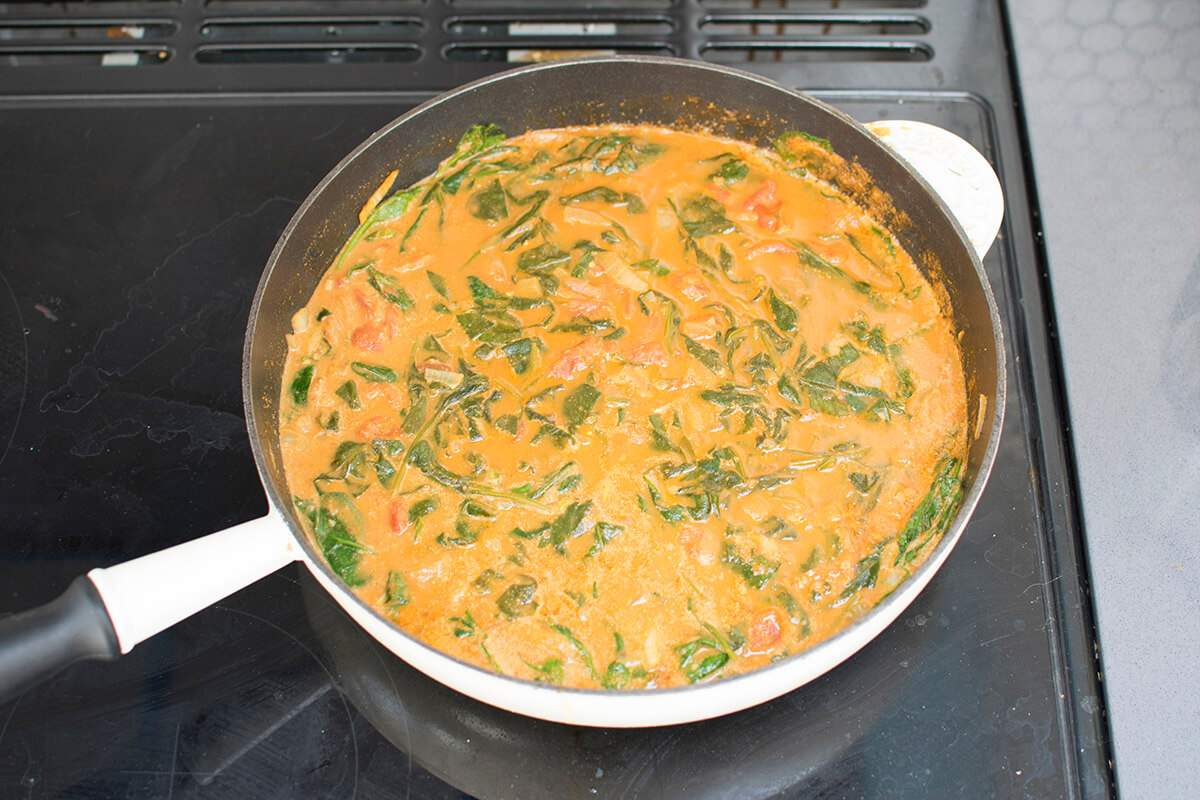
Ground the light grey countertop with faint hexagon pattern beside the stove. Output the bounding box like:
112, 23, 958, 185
1009, 0, 1200, 800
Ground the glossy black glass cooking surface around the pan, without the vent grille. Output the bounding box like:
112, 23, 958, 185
0, 92, 1074, 798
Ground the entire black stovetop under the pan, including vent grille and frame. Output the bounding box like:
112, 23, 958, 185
0, 0, 1115, 798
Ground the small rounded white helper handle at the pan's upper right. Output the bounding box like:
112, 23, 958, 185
866, 120, 1004, 258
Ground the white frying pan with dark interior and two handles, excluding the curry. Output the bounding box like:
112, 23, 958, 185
0, 56, 1004, 727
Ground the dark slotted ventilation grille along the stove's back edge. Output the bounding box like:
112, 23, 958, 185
0, 0, 934, 92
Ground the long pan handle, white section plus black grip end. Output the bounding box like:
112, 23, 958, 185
0, 510, 300, 702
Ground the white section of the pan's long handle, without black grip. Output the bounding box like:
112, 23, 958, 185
88, 509, 300, 654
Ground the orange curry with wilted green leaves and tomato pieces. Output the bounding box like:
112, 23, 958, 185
280, 126, 966, 688
